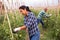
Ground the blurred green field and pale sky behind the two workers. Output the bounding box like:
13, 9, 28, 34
0, 0, 60, 40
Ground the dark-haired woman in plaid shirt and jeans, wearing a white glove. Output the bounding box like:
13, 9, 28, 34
13, 5, 40, 40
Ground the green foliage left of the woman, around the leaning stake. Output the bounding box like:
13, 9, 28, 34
0, 12, 26, 40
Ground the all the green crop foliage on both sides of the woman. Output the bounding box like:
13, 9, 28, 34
0, 9, 60, 40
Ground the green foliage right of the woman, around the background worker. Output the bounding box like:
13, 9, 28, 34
33, 9, 60, 40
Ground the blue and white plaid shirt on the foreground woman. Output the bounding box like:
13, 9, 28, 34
24, 12, 39, 36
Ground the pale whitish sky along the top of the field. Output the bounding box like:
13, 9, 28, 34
1, 0, 58, 8
